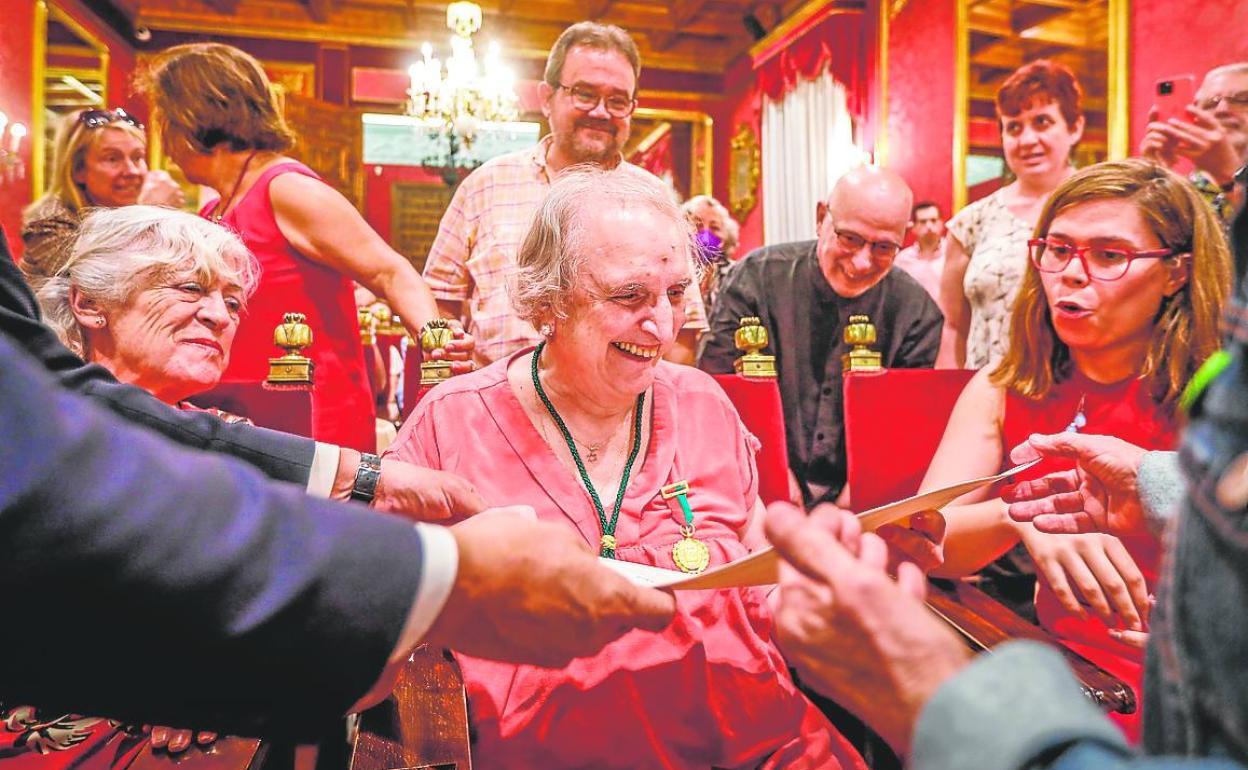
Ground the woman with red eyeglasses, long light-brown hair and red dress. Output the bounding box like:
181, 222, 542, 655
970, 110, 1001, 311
921, 160, 1232, 739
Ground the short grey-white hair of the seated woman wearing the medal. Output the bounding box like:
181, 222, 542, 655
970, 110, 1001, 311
510, 163, 698, 326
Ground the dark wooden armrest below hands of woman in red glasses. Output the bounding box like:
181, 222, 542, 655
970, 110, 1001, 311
927, 580, 1136, 714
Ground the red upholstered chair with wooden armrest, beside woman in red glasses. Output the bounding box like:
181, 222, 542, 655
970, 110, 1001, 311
844, 369, 1136, 714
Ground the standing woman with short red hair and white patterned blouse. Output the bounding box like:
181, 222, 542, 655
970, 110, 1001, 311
936, 59, 1083, 369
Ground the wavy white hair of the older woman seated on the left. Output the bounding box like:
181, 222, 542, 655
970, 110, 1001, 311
34, 206, 260, 354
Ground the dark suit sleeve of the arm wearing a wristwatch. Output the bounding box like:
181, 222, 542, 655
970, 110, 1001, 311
0, 232, 316, 484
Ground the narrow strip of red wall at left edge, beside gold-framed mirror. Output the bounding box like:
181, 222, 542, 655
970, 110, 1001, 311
0, 0, 35, 255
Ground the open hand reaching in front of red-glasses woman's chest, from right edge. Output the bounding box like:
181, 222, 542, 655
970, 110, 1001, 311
1001, 433, 1148, 535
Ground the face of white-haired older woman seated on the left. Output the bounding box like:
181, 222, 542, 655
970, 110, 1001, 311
82, 266, 243, 403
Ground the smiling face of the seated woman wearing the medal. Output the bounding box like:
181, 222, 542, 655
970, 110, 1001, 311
547, 203, 691, 408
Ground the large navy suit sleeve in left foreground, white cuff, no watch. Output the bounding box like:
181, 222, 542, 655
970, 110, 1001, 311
0, 334, 423, 736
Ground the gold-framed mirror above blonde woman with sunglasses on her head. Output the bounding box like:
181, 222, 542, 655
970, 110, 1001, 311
31, 0, 109, 197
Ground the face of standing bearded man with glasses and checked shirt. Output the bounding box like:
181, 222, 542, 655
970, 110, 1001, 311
538, 46, 636, 165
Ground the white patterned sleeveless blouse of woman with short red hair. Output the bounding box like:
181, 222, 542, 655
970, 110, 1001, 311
947, 190, 1033, 369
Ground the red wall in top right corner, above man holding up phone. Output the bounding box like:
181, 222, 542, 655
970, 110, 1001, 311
1131, 0, 1248, 154
